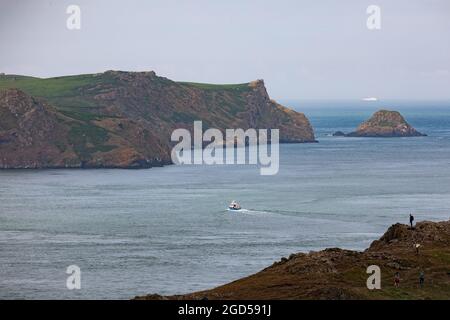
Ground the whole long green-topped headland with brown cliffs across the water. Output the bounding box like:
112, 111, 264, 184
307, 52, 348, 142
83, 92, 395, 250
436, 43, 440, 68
0, 71, 315, 169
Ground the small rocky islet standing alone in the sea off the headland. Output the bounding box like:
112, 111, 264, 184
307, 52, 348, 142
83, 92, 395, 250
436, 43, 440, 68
333, 110, 426, 138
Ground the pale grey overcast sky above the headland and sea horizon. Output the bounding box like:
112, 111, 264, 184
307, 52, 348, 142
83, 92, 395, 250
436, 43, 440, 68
0, 0, 450, 99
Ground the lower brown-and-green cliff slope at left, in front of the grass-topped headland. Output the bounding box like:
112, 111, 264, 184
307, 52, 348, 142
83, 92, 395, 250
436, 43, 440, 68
0, 89, 168, 169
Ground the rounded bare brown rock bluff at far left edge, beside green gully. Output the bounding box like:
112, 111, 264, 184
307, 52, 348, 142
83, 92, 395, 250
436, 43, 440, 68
0, 89, 76, 168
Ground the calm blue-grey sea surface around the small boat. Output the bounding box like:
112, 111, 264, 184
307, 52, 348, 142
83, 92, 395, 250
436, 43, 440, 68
0, 101, 450, 299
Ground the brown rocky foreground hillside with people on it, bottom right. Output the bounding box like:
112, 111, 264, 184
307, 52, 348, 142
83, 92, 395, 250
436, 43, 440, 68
136, 221, 450, 300
